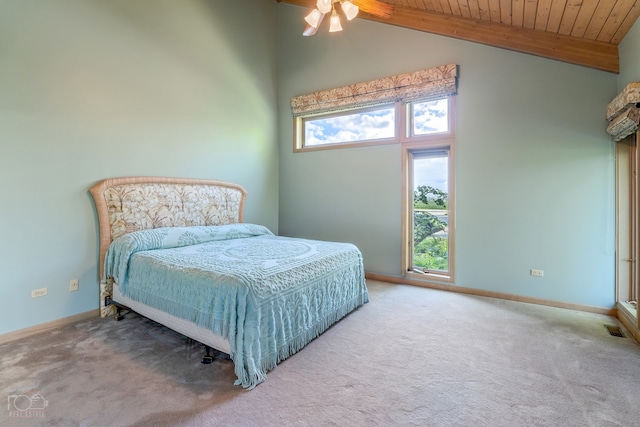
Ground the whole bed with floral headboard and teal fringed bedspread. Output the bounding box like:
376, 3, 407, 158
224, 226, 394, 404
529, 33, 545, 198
90, 177, 369, 389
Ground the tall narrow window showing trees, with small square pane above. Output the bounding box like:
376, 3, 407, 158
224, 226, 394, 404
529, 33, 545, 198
402, 98, 455, 282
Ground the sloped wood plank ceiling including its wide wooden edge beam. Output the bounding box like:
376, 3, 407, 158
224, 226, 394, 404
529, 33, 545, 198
277, 0, 640, 73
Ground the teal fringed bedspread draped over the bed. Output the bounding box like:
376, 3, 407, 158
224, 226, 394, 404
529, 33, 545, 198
105, 224, 369, 389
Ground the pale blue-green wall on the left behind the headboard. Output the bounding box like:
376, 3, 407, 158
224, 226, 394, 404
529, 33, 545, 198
0, 0, 278, 334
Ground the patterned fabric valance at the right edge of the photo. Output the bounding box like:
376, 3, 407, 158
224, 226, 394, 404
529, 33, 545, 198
607, 82, 640, 141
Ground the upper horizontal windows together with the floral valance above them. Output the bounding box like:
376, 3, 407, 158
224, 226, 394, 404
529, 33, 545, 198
291, 64, 458, 152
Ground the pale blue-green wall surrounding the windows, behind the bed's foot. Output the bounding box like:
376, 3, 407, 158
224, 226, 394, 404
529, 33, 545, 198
278, 5, 617, 307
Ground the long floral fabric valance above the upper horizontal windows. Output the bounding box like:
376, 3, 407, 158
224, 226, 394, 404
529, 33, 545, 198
291, 64, 458, 117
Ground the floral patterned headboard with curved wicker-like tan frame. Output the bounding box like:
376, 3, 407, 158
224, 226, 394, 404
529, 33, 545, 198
89, 177, 247, 316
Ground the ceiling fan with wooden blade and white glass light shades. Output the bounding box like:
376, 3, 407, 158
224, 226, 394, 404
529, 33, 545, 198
302, 0, 393, 36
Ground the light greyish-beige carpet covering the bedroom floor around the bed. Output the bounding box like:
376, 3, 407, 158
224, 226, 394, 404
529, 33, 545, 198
0, 281, 640, 427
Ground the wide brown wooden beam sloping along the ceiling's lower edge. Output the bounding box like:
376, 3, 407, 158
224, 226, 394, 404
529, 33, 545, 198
277, 0, 620, 73
